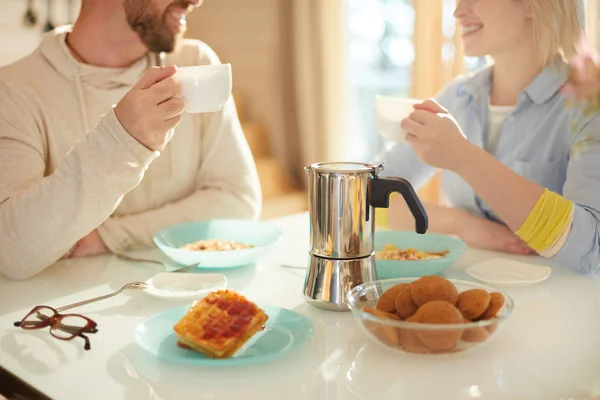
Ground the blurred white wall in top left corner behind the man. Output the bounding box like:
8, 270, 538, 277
0, 0, 80, 66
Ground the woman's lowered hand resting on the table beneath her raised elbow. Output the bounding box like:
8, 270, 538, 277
458, 215, 536, 255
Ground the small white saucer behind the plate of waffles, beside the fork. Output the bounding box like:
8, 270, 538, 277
144, 272, 227, 299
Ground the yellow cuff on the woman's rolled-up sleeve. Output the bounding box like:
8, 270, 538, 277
516, 189, 573, 252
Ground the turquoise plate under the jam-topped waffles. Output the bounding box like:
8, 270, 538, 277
134, 305, 314, 366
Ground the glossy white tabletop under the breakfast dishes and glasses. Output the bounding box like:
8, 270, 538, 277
0, 214, 600, 400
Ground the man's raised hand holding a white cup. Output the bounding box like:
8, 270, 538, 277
115, 66, 184, 150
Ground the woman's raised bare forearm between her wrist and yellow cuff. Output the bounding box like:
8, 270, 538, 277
455, 146, 544, 231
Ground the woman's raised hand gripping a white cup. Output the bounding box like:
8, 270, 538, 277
401, 100, 476, 171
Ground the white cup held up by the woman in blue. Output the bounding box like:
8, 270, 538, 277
375, 95, 421, 142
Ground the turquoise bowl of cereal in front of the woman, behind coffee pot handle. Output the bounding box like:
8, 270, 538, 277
375, 231, 467, 279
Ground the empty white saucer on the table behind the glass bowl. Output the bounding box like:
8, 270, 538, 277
466, 258, 552, 286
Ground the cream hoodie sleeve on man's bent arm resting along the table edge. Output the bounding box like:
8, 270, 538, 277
98, 94, 262, 253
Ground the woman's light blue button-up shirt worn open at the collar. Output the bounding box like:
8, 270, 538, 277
381, 63, 600, 273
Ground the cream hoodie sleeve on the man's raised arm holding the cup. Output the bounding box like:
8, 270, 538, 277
0, 82, 158, 279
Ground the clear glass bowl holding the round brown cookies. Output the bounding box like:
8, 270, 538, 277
348, 278, 513, 357
